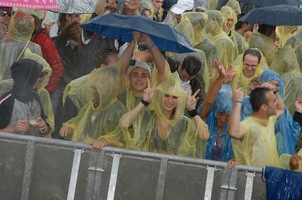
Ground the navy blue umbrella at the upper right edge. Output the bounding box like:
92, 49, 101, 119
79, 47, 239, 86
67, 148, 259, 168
239, 5, 302, 26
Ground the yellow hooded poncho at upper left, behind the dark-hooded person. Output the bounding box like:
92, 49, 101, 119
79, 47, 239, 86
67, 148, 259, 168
0, 10, 42, 80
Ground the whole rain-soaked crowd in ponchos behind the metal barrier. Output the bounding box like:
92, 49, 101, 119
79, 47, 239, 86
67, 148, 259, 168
0, 0, 302, 170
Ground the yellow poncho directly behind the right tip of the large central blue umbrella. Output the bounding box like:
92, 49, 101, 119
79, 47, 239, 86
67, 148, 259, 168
182, 12, 219, 85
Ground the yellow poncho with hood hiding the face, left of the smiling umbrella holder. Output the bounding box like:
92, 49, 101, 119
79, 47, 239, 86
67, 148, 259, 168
63, 66, 126, 147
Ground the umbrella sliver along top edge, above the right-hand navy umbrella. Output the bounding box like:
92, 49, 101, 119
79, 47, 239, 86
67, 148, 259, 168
238, 0, 302, 7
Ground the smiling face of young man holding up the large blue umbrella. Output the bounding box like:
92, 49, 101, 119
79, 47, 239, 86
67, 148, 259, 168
129, 67, 149, 92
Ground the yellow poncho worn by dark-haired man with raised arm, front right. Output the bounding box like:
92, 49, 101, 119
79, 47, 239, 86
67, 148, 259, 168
232, 116, 280, 167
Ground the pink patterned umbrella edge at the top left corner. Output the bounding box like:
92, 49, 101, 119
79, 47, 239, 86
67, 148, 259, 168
0, 0, 59, 10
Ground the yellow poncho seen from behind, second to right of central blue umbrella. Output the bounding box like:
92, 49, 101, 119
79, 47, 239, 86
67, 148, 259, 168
206, 10, 238, 66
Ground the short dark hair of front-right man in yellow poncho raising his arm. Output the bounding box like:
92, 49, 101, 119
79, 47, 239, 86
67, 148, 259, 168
250, 88, 271, 112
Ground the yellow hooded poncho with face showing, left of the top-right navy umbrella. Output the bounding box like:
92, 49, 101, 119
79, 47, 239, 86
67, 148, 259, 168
220, 6, 248, 55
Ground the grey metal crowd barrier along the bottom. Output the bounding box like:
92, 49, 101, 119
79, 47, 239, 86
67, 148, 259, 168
0, 133, 266, 200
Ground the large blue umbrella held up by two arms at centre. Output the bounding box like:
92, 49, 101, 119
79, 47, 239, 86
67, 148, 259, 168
81, 13, 194, 53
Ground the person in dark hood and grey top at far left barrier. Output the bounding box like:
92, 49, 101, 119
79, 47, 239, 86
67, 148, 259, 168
0, 59, 50, 136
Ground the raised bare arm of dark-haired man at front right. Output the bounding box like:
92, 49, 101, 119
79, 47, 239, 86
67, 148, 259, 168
228, 88, 244, 140
